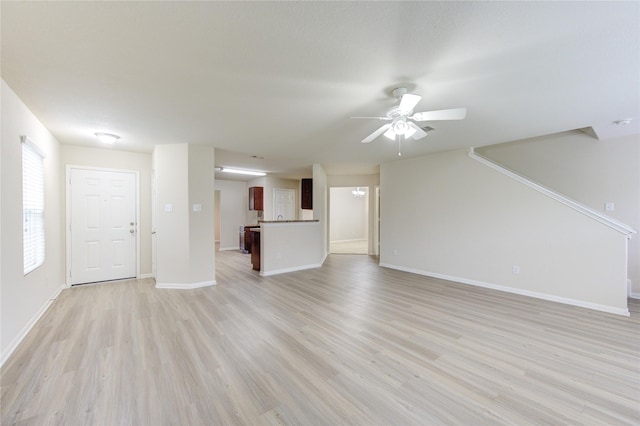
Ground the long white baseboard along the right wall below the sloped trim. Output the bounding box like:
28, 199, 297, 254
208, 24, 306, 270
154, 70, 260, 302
380, 263, 630, 317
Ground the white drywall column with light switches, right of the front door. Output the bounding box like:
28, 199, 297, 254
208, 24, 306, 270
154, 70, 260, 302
153, 144, 216, 288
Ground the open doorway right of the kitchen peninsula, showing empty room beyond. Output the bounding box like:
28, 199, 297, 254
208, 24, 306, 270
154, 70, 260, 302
329, 187, 369, 254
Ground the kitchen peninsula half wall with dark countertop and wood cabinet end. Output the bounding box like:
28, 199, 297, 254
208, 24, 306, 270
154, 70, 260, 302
250, 220, 326, 276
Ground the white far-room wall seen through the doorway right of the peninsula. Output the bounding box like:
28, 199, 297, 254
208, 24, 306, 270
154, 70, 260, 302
329, 187, 369, 242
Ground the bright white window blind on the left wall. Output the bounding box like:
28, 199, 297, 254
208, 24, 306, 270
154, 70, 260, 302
22, 136, 44, 275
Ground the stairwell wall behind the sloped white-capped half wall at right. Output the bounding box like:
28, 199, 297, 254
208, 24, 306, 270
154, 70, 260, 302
477, 131, 640, 297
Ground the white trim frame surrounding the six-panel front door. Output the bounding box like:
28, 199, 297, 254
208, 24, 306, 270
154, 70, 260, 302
65, 164, 140, 288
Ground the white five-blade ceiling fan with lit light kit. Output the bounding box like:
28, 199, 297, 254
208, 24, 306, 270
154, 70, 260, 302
351, 87, 467, 155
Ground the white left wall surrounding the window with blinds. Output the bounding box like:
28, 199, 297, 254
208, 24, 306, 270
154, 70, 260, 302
0, 80, 64, 363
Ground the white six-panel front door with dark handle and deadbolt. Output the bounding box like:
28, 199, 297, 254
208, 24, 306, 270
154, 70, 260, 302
69, 168, 137, 284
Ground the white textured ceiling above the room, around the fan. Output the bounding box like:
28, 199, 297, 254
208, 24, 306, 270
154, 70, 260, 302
0, 1, 640, 177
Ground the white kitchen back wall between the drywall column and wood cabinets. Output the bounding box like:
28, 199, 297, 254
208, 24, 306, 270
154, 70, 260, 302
216, 179, 246, 250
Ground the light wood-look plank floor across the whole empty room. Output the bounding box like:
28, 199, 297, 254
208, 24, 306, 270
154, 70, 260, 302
1, 251, 640, 425
